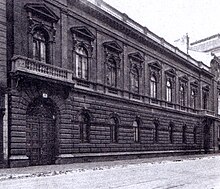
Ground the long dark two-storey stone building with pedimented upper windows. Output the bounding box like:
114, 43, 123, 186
0, 0, 220, 167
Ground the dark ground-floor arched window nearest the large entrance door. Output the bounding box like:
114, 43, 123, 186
79, 113, 91, 142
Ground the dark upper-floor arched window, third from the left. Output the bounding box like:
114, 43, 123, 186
107, 58, 117, 87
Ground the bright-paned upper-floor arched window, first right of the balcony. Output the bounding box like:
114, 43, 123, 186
76, 46, 88, 80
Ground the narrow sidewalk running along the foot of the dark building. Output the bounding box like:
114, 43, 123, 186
0, 153, 220, 181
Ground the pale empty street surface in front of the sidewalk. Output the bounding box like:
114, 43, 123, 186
0, 156, 220, 189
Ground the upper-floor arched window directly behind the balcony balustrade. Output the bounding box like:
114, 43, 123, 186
33, 30, 48, 63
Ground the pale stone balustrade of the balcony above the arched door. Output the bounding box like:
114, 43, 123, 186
11, 56, 73, 83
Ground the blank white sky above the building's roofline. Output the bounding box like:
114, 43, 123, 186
104, 0, 220, 44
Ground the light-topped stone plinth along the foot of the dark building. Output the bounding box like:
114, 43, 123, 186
8, 149, 215, 168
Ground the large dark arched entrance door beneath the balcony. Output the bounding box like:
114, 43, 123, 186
27, 100, 55, 165
